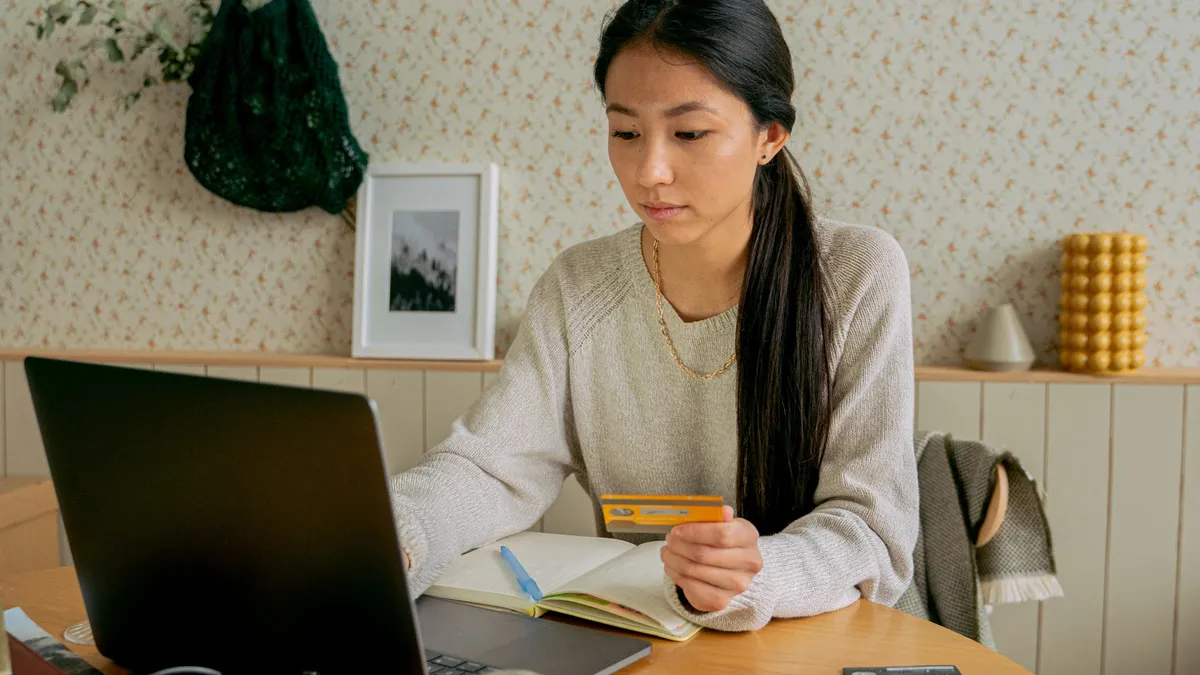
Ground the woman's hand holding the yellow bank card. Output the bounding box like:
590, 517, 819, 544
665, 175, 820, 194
661, 506, 762, 613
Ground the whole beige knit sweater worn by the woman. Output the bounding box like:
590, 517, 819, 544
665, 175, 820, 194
391, 221, 918, 631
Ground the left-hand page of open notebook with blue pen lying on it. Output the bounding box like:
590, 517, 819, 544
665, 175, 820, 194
430, 532, 634, 602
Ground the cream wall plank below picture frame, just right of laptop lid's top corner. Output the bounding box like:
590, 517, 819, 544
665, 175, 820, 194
366, 370, 425, 473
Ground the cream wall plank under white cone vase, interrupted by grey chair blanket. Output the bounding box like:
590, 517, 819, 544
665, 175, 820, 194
982, 382, 1045, 673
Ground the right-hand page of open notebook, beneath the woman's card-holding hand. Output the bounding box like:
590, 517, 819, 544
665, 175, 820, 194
547, 542, 691, 632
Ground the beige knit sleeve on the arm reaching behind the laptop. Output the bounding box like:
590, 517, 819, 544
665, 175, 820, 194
390, 264, 575, 597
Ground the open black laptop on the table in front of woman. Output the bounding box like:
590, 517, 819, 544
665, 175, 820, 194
25, 357, 650, 675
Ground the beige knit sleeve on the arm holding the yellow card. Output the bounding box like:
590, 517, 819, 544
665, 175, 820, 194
666, 228, 919, 631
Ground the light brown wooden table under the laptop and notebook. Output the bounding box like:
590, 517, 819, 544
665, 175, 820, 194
0, 567, 1030, 675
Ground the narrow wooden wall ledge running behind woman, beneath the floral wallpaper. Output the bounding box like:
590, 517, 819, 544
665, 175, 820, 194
0, 348, 1200, 384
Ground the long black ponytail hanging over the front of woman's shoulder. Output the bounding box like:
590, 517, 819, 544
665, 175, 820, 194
737, 149, 833, 536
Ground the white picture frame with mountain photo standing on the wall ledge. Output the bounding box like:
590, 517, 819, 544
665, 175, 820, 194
350, 162, 500, 360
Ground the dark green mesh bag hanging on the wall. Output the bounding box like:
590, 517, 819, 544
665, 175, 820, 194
184, 0, 367, 214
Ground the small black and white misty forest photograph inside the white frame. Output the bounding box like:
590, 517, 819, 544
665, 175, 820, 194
388, 211, 460, 312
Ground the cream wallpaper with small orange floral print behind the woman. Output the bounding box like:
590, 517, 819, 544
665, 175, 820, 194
0, 0, 1200, 366
